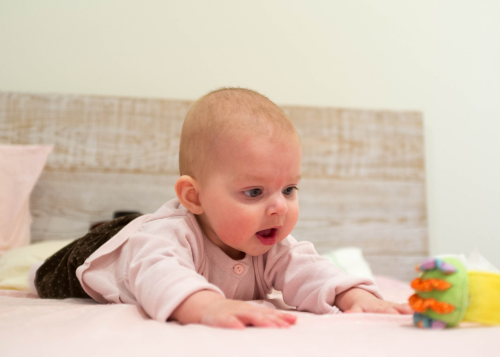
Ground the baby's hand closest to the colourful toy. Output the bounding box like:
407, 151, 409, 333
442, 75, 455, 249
335, 288, 413, 314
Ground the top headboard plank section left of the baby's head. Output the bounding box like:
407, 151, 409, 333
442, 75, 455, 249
0, 93, 191, 175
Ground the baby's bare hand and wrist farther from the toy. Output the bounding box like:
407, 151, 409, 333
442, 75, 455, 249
170, 290, 297, 329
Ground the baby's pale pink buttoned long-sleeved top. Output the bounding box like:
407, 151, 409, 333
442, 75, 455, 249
76, 199, 381, 321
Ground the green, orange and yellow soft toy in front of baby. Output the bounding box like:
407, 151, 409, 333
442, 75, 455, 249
409, 257, 500, 329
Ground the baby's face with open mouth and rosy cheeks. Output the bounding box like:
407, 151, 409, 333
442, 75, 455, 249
197, 129, 302, 259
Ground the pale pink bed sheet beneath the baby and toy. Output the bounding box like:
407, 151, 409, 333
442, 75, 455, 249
0, 277, 500, 357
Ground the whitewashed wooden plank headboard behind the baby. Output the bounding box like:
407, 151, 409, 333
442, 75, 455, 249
0, 92, 428, 280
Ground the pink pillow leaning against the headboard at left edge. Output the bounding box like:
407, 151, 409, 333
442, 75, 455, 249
0, 145, 52, 256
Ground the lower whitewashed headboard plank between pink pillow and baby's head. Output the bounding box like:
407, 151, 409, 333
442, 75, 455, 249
31, 171, 177, 241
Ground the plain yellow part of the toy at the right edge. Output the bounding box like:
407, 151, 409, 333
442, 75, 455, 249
464, 271, 500, 325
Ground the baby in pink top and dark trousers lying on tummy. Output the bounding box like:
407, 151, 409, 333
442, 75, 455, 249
35, 88, 411, 329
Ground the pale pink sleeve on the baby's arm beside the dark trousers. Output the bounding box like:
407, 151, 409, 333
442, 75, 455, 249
76, 217, 224, 322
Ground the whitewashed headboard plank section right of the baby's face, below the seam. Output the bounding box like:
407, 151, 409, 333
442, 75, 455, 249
292, 178, 427, 255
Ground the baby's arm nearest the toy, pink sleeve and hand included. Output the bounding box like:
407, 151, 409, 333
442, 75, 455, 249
264, 236, 412, 314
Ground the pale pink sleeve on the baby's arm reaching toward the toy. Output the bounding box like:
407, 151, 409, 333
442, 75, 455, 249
264, 236, 382, 314
